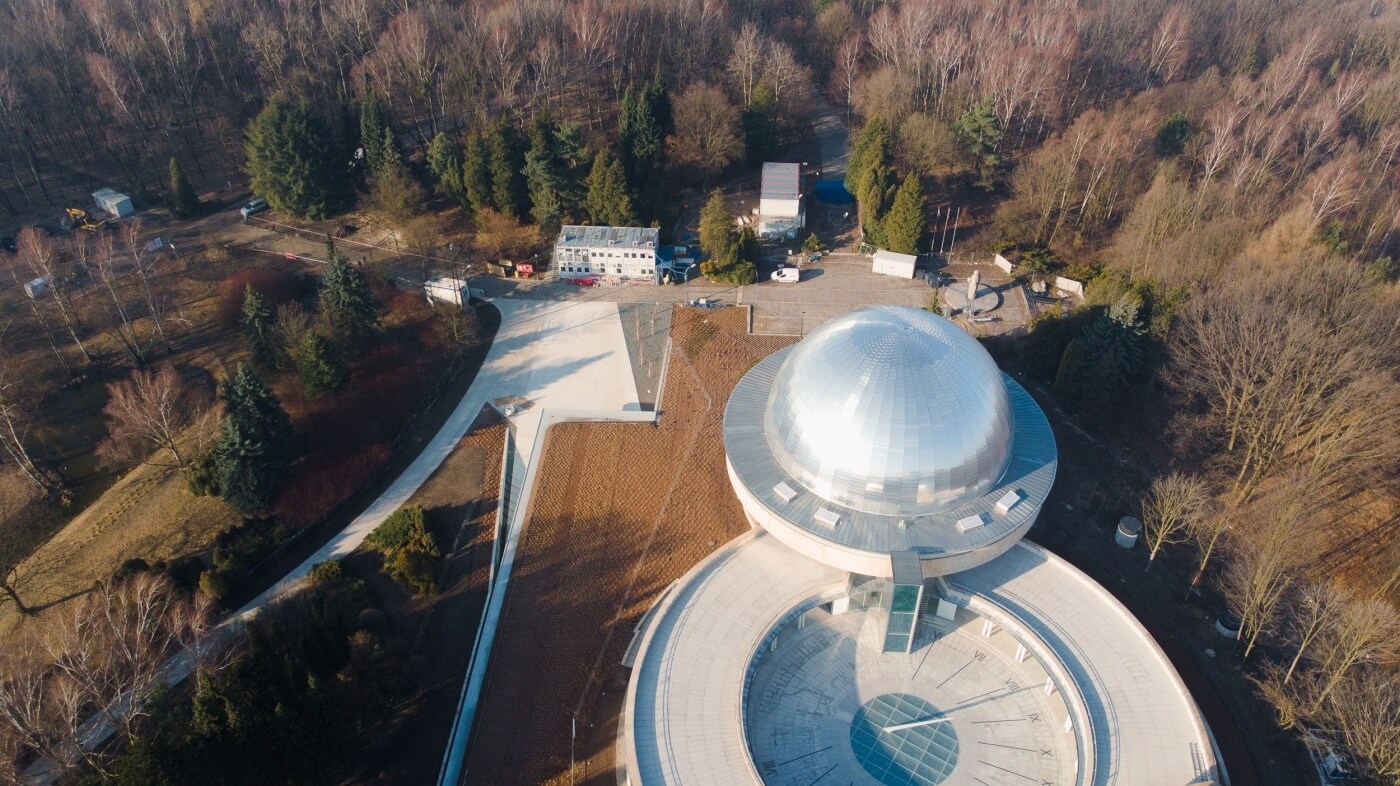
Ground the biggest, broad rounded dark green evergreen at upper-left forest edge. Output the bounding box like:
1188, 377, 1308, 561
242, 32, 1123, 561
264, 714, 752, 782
244, 94, 346, 219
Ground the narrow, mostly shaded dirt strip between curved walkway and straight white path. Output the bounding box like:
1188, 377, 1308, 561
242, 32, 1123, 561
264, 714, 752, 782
346, 408, 507, 786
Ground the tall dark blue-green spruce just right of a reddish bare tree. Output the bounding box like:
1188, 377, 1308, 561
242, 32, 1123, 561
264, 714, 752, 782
214, 366, 293, 514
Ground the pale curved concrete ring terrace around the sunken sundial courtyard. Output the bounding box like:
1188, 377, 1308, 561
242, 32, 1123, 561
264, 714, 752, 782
619, 530, 1225, 786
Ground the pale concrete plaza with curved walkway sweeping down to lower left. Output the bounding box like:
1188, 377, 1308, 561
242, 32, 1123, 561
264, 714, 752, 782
27, 300, 641, 786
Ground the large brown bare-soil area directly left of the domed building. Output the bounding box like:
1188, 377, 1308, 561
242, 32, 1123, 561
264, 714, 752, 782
466, 307, 794, 786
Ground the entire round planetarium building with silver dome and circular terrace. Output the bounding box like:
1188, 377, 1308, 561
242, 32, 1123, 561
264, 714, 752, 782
619, 308, 1228, 786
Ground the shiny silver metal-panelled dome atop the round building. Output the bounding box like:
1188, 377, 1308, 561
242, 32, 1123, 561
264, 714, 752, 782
763, 307, 1012, 517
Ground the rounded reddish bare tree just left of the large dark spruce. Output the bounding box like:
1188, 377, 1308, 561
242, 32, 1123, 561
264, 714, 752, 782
102, 366, 211, 469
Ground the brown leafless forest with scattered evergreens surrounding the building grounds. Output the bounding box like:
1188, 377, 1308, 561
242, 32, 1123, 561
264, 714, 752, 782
0, 0, 1400, 783
